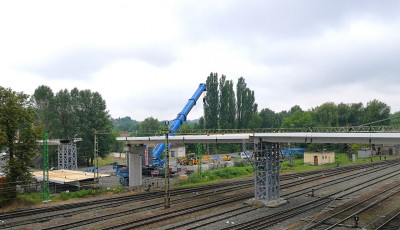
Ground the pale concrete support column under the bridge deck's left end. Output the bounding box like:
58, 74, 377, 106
126, 145, 146, 187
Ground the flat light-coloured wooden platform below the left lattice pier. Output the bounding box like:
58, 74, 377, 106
32, 170, 111, 184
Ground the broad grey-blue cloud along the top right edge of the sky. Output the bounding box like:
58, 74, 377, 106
179, 0, 399, 42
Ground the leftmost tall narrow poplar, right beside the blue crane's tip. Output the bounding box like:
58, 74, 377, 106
204, 73, 219, 129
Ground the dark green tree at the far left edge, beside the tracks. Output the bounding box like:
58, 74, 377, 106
0, 87, 41, 198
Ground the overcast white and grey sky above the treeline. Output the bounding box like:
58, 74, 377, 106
0, 0, 400, 120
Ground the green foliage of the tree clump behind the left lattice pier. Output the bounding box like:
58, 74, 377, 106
32, 86, 114, 166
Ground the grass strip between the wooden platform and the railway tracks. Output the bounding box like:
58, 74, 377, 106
17, 185, 125, 204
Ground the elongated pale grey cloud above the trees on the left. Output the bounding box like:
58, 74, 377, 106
25, 46, 176, 79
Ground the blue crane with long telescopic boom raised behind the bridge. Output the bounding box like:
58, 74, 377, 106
151, 83, 207, 167
